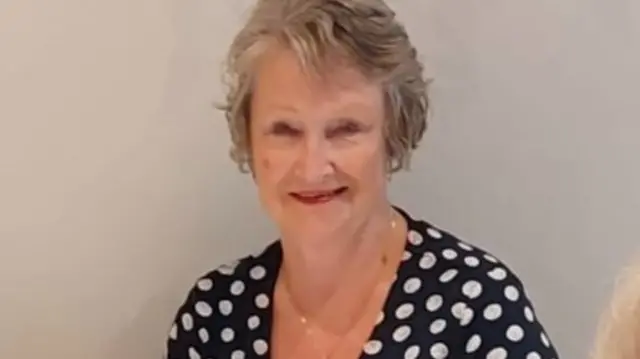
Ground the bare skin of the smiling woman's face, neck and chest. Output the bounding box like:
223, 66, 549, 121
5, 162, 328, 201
251, 47, 407, 359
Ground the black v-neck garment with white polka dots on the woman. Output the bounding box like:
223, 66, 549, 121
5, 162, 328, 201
165, 208, 558, 359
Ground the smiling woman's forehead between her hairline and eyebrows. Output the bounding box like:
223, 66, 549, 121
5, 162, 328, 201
252, 46, 383, 116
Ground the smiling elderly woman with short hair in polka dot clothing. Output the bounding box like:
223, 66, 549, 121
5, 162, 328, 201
167, 0, 557, 359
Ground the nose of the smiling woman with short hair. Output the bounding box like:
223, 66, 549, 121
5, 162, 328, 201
297, 138, 333, 184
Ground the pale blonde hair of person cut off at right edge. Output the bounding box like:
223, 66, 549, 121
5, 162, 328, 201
592, 260, 640, 359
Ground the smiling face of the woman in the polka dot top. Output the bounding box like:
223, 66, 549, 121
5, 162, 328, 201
250, 49, 388, 240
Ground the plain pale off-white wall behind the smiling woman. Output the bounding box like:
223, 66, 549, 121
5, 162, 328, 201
0, 0, 640, 359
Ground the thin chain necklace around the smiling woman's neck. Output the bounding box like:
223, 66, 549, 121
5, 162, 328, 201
284, 212, 397, 359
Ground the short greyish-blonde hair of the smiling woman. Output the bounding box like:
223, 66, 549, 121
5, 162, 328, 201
221, 0, 429, 173
